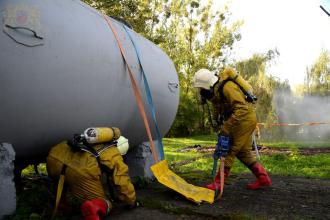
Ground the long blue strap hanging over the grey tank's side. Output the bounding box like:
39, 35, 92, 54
123, 25, 165, 160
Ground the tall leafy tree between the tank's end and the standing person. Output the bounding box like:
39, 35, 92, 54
155, 0, 241, 135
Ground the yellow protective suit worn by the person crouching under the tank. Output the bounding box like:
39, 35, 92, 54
47, 141, 136, 208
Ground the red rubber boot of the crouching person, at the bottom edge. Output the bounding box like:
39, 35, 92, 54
81, 199, 108, 220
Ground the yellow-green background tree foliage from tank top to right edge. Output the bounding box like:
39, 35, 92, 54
80, 0, 330, 140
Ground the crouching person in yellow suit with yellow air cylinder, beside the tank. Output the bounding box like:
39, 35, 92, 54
47, 128, 138, 220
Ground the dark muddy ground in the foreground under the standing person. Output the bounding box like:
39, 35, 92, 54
108, 147, 330, 220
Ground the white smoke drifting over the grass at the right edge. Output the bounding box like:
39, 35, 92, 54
273, 91, 330, 141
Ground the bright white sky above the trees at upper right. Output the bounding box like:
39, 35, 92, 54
214, 0, 330, 88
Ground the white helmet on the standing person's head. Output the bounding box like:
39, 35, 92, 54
193, 69, 218, 90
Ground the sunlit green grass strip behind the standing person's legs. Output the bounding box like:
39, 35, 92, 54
163, 135, 330, 178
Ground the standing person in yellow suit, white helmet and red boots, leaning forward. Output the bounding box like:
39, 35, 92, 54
193, 68, 272, 190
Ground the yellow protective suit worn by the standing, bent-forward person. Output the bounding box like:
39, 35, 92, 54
210, 69, 257, 169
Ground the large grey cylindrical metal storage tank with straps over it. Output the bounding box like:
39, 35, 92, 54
0, 0, 179, 161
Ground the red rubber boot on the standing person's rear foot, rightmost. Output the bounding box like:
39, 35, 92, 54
246, 162, 272, 190
